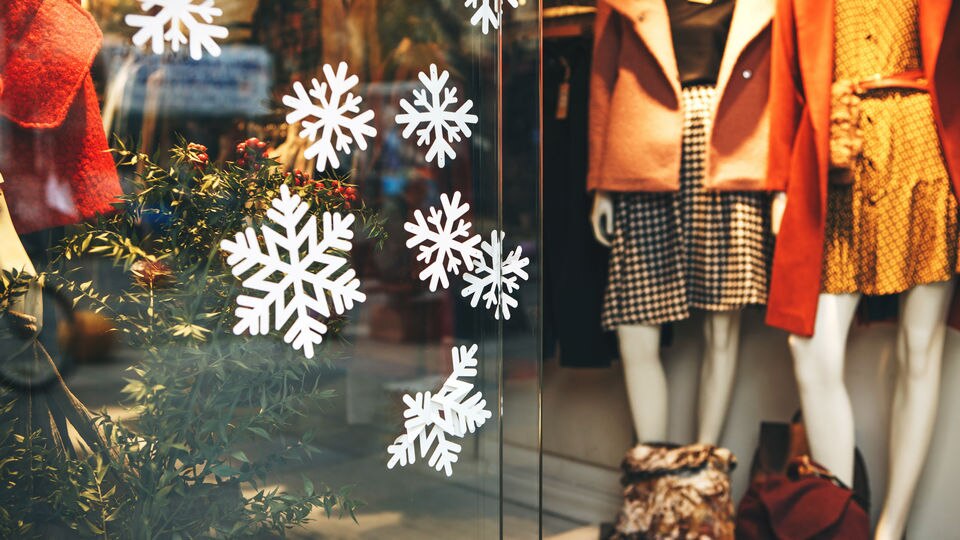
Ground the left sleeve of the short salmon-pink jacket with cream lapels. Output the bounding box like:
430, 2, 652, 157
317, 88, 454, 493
587, 0, 621, 190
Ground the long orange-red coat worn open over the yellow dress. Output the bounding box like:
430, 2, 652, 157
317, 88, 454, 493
767, 0, 960, 336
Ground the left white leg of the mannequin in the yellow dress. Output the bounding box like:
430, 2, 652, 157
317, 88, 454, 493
789, 294, 860, 486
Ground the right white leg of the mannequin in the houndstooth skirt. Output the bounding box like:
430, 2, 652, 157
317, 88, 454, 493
697, 310, 742, 444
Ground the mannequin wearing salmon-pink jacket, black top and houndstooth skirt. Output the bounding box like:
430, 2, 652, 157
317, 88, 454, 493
588, 0, 773, 452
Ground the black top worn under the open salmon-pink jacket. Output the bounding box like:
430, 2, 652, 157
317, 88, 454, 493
666, 0, 736, 86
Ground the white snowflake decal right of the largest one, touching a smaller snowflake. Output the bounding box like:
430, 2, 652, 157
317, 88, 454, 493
403, 191, 483, 291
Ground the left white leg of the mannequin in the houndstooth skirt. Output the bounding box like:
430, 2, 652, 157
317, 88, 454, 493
617, 325, 667, 442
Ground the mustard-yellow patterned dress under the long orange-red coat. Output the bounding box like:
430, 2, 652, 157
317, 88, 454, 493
823, 0, 958, 295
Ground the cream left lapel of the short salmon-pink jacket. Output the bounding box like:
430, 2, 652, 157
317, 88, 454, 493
604, 0, 680, 95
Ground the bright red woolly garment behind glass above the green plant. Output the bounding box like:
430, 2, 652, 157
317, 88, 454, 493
0, 0, 121, 234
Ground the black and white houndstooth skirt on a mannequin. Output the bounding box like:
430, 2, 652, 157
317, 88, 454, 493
602, 86, 773, 330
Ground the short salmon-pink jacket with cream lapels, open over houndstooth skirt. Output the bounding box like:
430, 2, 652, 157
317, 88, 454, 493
587, 0, 775, 191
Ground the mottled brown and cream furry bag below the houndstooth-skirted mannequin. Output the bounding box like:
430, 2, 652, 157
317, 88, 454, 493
606, 444, 736, 540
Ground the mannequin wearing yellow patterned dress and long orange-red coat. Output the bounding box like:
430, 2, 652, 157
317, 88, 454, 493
768, 0, 960, 540
